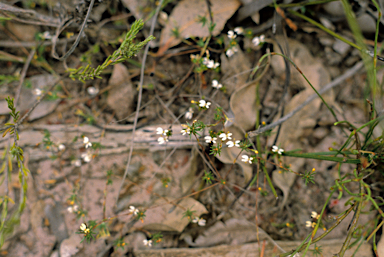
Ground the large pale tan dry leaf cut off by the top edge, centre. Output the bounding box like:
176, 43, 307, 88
158, 0, 240, 55
